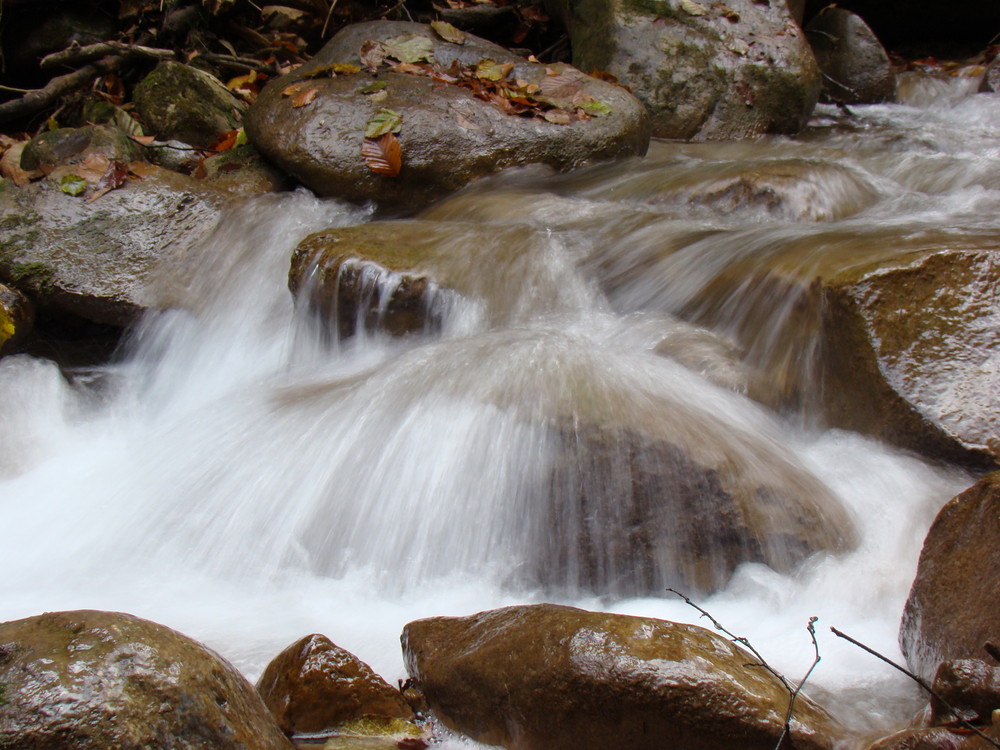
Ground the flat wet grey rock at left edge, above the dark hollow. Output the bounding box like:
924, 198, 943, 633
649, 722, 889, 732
0, 171, 223, 326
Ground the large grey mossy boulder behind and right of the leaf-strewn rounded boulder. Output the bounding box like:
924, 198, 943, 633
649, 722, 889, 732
548, 0, 820, 140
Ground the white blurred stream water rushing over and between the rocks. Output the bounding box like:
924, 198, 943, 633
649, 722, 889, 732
0, 72, 1000, 746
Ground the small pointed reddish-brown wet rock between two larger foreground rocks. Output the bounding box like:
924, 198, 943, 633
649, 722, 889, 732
257, 634, 419, 735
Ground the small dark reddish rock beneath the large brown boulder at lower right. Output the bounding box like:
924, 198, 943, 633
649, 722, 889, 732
930, 659, 1000, 726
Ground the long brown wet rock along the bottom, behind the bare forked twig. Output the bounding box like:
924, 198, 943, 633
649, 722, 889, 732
402, 604, 840, 750
